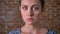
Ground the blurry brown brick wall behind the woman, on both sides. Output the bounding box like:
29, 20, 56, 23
0, 0, 60, 34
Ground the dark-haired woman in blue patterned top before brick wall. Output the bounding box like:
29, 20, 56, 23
8, 0, 56, 34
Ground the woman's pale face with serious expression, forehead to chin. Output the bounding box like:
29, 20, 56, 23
20, 0, 42, 24
